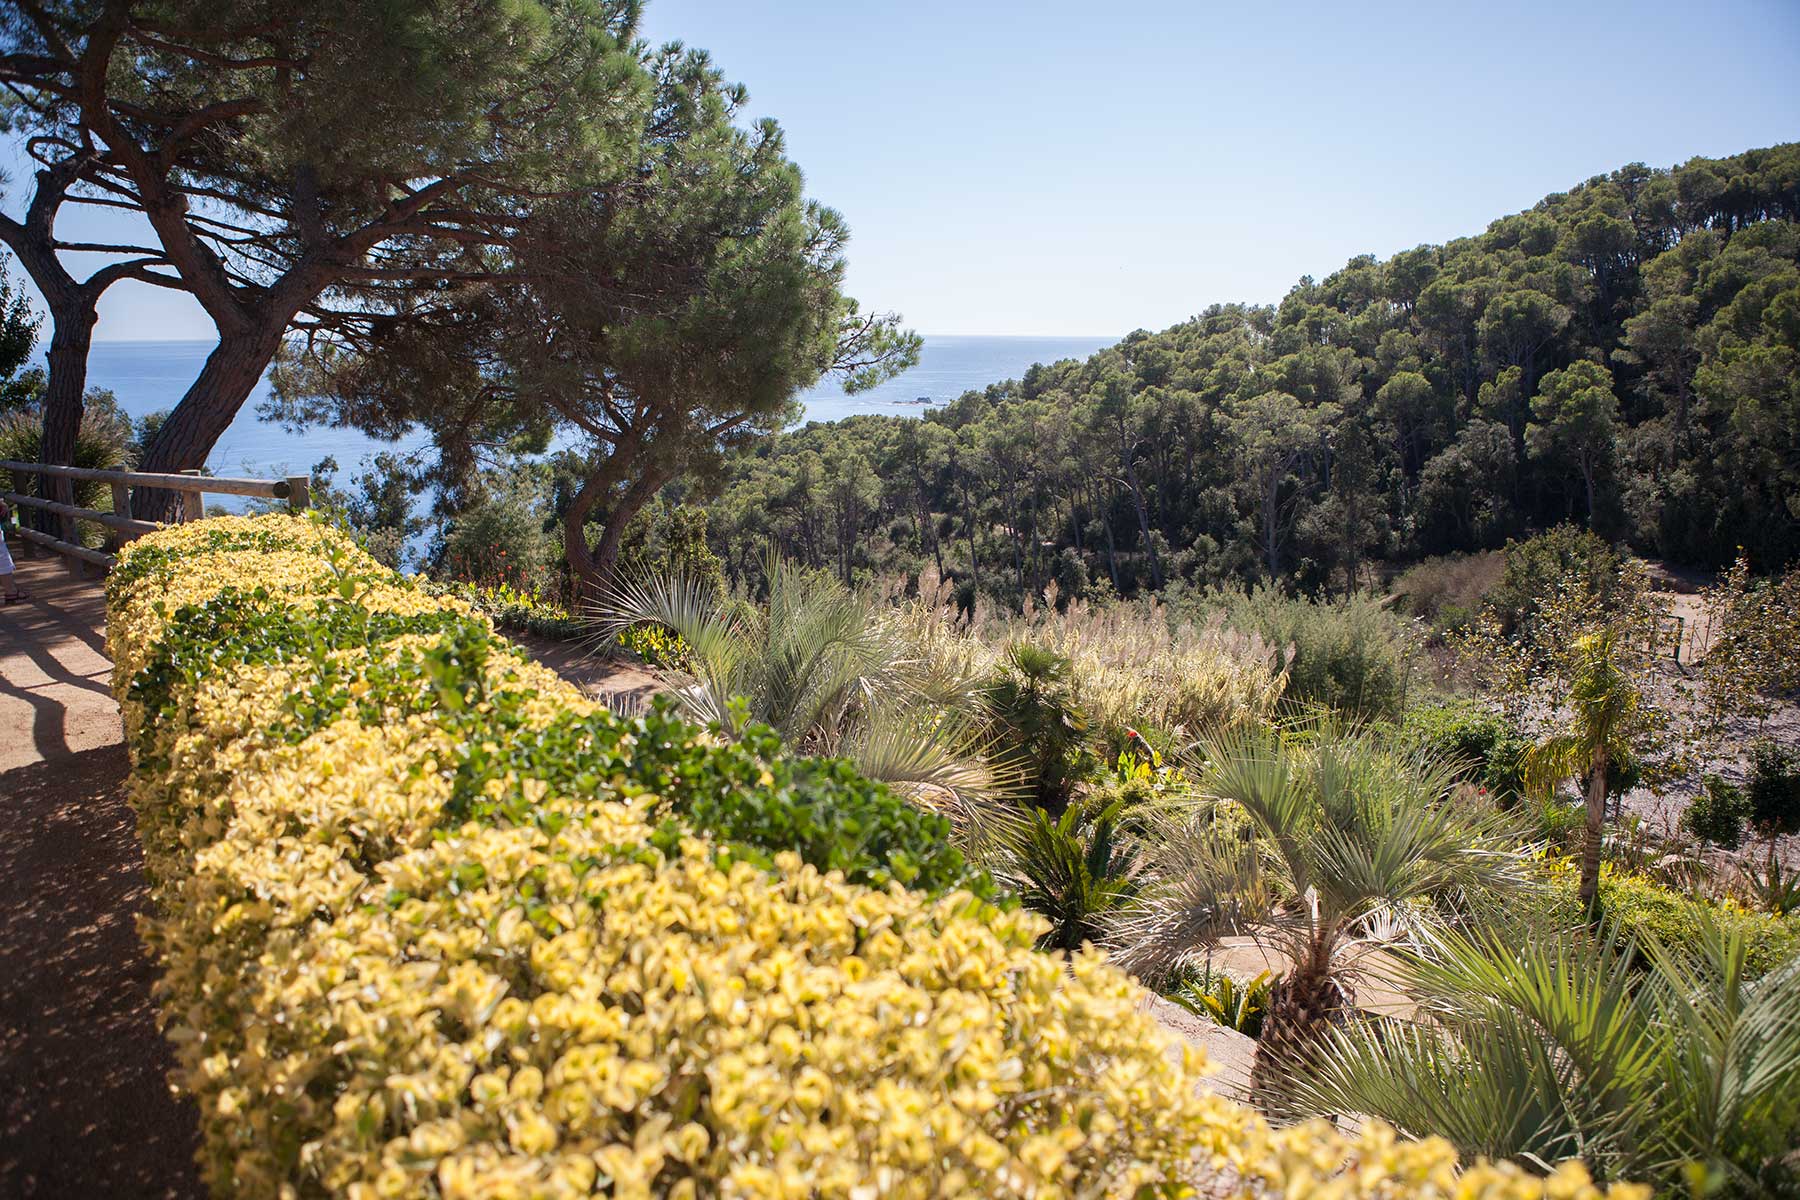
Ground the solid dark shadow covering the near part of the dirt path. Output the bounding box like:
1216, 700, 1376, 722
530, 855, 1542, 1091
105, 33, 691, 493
0, 745, 205, 1200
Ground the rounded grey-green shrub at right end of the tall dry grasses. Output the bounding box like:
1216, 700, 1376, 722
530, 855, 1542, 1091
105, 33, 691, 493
1202, 587, 1415, 720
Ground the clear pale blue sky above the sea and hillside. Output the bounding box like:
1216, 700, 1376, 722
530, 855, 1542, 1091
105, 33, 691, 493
9, 0, 1800, 338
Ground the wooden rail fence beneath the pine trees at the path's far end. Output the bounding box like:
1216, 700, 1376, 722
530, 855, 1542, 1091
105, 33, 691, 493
0, 459, 311, 570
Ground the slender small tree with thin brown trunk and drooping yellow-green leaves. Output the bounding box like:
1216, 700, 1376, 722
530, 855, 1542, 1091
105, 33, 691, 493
1525, 626, 1642, 912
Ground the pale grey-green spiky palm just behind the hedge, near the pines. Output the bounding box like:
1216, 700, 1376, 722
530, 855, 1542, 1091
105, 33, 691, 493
587, 556, 1006, 828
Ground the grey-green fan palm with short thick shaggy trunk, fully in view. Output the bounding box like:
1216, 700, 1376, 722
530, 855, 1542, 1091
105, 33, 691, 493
1111, 723, 1519, 1114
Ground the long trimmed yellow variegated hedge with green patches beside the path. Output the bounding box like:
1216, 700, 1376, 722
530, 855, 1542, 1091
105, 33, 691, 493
108, 516, 1642, 1200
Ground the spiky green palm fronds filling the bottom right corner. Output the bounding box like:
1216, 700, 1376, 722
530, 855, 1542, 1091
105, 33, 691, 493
1296, 923, 1800, 1196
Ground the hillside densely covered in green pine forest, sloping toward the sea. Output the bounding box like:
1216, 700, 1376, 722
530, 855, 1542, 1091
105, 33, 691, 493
711, 144, 1800, 597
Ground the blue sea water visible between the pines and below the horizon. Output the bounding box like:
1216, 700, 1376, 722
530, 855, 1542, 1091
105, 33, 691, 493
88, 336, 1118, 477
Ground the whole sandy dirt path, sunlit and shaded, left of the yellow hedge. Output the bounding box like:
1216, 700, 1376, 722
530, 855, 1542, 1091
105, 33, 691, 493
0, 560, 203, 1198
